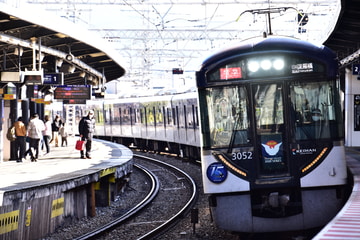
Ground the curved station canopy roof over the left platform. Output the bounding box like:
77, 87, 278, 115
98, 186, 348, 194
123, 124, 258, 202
0, 4, 125, 86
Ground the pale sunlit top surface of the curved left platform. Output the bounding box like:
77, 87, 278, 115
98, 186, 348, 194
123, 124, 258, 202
0, 137, 132, 193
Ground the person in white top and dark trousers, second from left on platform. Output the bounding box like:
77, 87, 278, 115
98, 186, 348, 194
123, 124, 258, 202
28, 113, 45, 162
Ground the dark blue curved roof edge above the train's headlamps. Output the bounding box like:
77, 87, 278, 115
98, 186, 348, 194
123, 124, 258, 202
202, 36, 337, 70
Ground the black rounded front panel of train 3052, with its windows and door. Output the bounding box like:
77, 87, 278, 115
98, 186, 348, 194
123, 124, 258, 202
199, 50, 344, 179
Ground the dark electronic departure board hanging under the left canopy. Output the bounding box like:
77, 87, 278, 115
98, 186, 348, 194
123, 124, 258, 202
54, 85, 91, 99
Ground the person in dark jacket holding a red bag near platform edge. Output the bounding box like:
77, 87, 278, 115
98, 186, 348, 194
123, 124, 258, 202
79, 110, 95, 159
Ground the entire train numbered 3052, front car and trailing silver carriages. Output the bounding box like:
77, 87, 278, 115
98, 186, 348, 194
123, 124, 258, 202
65, 36, 348, 233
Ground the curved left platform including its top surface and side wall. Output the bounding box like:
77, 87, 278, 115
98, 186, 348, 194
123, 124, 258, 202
0, 137, 133, 239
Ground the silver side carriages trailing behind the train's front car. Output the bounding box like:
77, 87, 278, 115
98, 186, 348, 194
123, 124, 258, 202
64, 92, 200, 159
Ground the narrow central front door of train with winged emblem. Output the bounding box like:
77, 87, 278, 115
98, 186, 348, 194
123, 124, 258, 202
252, 83, 290, 186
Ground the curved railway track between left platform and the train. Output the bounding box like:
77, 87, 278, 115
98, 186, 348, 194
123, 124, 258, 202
75, 155, 197, 240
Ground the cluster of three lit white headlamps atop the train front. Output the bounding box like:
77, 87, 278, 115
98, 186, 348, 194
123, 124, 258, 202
247, 58, 285, 73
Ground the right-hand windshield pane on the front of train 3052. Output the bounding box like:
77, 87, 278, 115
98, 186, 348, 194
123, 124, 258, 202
290, 81, 342, 140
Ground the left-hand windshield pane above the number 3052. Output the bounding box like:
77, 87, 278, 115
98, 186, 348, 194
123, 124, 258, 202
206, 86, 250, 147
